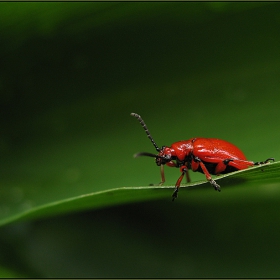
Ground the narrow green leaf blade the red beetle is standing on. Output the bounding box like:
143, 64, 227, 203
0, 162, 280, 225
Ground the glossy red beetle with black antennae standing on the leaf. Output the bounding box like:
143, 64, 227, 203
131, 113, 274, 201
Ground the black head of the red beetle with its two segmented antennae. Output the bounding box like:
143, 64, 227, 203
130, 113, 171, 166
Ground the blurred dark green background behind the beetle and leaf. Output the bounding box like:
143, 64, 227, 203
0, 2, 280, 278
